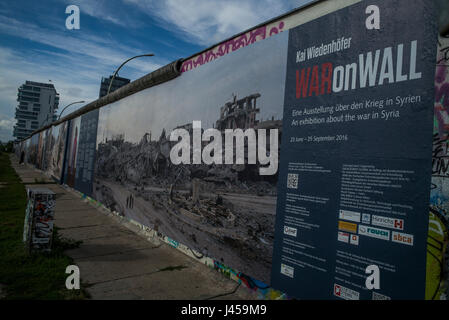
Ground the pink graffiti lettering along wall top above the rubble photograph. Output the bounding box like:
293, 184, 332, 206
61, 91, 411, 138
181, 21, 285, 72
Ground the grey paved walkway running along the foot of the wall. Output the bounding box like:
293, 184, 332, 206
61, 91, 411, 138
11, 156, 256, 300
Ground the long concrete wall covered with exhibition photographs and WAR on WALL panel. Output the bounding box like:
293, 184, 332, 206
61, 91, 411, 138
16, 0, 449, 299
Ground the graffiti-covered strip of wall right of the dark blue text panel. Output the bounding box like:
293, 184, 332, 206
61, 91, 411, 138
426, 37, 449, 300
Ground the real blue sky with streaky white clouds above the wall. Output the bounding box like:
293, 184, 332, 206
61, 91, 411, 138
0, 0, 310, 141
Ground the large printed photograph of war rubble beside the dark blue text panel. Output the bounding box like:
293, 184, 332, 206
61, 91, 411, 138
93, 33, 288, 284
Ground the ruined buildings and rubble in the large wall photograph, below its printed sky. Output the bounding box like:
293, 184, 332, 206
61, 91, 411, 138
93, 93, 282, 283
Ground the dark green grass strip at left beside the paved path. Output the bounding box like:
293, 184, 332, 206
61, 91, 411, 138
0, 153, 88, 300
